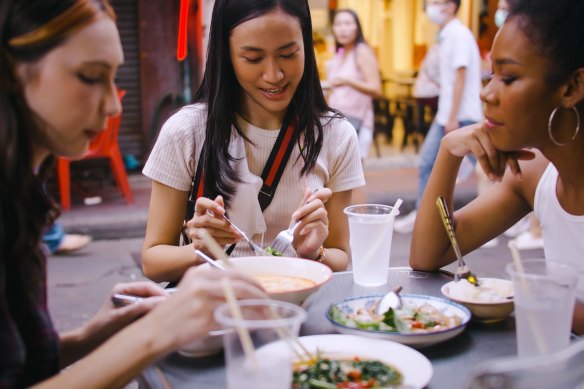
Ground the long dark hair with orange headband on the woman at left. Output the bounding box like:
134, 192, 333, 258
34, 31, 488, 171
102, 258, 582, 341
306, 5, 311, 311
0, 0, 113, 285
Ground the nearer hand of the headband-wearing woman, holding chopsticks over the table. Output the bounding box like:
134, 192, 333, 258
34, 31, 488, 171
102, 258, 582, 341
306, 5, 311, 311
144, 267, 268, 349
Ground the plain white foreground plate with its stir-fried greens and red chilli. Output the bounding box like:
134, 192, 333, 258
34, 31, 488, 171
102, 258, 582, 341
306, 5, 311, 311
256, 334, 434, 389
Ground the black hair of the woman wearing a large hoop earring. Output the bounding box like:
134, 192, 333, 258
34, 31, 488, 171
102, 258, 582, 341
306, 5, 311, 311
508, 0, 584, 87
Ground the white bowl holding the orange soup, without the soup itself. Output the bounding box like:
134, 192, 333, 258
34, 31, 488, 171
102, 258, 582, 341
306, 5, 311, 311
201, 256, 333, 305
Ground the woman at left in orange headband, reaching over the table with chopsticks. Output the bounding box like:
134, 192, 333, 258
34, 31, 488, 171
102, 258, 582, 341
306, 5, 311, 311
0, 0, 265, 388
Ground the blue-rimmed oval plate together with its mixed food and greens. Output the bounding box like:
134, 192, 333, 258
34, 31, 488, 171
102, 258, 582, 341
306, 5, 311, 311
326, 294, 471, 348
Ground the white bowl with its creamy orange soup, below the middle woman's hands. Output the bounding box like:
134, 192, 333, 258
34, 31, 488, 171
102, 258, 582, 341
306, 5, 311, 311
201, 256, 332, 305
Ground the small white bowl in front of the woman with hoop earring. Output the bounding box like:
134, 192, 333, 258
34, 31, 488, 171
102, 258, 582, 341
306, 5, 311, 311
440, 278, 514, 323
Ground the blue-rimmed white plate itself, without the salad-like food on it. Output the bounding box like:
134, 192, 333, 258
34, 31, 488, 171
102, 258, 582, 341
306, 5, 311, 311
326, 294, 471, 348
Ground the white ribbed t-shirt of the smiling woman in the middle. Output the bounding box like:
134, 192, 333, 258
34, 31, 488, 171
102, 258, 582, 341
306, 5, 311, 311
143, 104, 365, 256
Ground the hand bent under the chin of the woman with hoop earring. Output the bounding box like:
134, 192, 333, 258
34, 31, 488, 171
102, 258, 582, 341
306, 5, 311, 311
442, 122, 535, 181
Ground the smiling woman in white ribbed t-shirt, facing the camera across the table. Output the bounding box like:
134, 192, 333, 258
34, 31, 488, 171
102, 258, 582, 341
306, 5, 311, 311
142, 0, 364, 281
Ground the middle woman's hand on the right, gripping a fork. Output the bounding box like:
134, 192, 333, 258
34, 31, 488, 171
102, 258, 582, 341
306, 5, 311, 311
292, 188, 332, 259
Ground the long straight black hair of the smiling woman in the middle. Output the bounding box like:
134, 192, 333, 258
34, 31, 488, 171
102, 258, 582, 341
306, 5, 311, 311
195, 0, 330, 203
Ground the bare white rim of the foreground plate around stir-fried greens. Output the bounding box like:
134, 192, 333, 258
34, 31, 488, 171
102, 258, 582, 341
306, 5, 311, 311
274, 334, 434, 388
